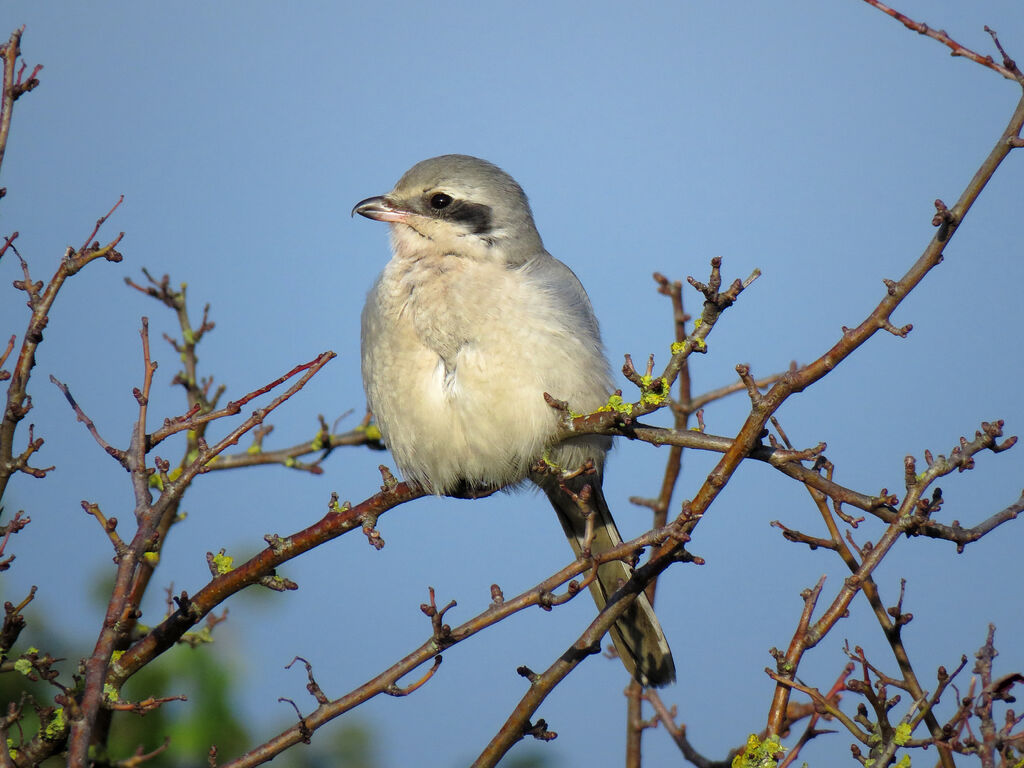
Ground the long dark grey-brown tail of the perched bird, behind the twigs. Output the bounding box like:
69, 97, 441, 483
545, 475, 676, 687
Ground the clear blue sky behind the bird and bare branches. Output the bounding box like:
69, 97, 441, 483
0, 0, 1024, 766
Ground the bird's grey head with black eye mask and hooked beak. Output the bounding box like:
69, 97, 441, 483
352, 155, 544, 264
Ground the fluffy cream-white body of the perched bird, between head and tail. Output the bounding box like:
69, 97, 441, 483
362, 249, 611, 493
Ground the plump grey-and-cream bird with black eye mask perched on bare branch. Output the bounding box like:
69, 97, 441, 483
352, 155, 676, 686
